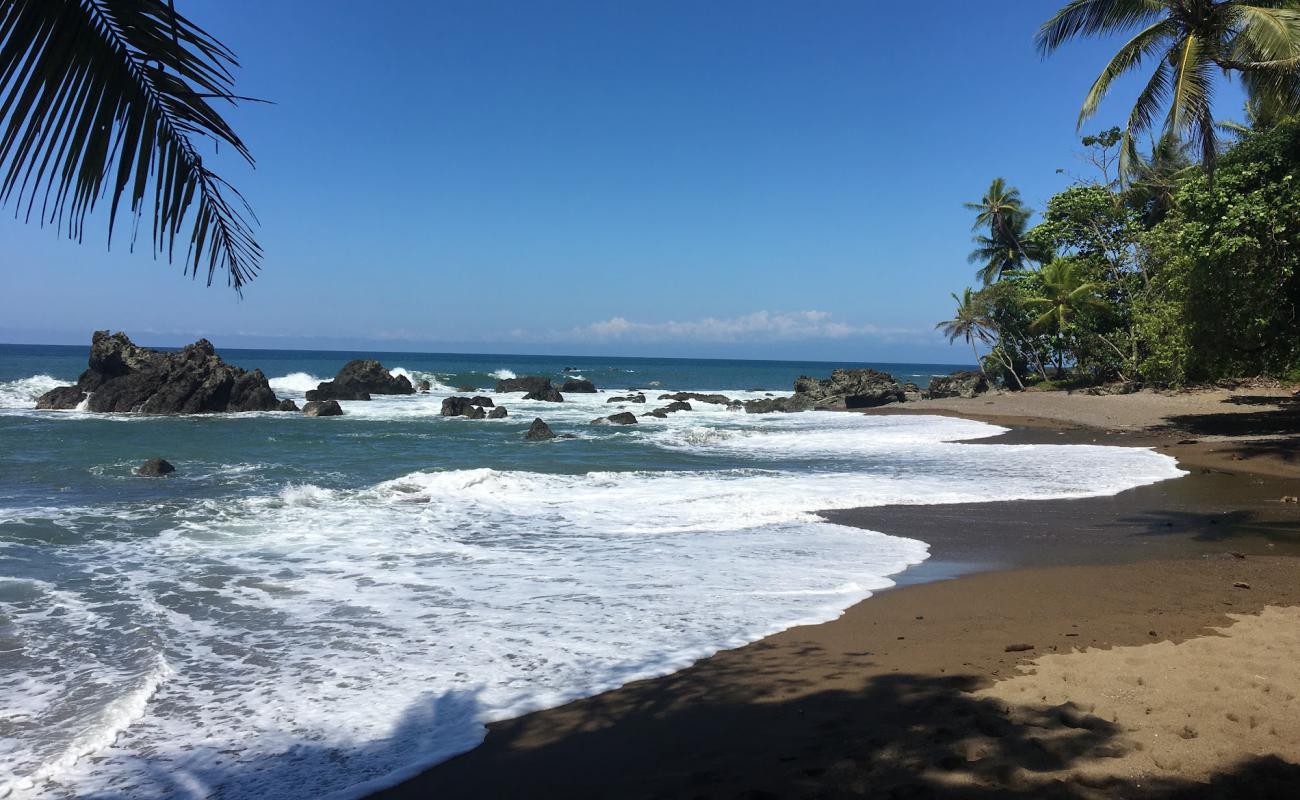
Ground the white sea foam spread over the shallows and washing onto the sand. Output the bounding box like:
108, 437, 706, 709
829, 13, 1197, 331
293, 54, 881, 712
0, 411, 1180, 799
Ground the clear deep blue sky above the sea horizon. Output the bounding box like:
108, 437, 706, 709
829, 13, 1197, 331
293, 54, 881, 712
0, 0, 1240, 362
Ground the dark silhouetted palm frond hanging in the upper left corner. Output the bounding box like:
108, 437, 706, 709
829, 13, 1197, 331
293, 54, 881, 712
0, 0, 261, 291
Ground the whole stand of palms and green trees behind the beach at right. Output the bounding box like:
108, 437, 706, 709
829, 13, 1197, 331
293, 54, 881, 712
940, 0, 1300, 389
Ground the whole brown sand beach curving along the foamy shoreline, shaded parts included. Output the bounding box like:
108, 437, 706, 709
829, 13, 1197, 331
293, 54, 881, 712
377, 389, 1300, 799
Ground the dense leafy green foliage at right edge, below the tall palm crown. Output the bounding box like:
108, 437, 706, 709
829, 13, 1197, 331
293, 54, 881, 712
1140, 118, 1300, 382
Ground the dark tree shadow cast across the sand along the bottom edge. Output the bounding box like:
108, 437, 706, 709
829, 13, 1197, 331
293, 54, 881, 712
378, 643, 1300, 800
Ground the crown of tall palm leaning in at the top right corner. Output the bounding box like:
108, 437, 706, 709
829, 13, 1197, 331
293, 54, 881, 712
1036, 0, 1300, 177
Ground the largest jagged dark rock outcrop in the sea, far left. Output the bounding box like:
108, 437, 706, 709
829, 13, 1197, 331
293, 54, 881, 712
36, 330, 280, 414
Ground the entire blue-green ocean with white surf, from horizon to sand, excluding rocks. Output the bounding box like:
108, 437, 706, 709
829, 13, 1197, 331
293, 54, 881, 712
0, 345, 1180, 800
